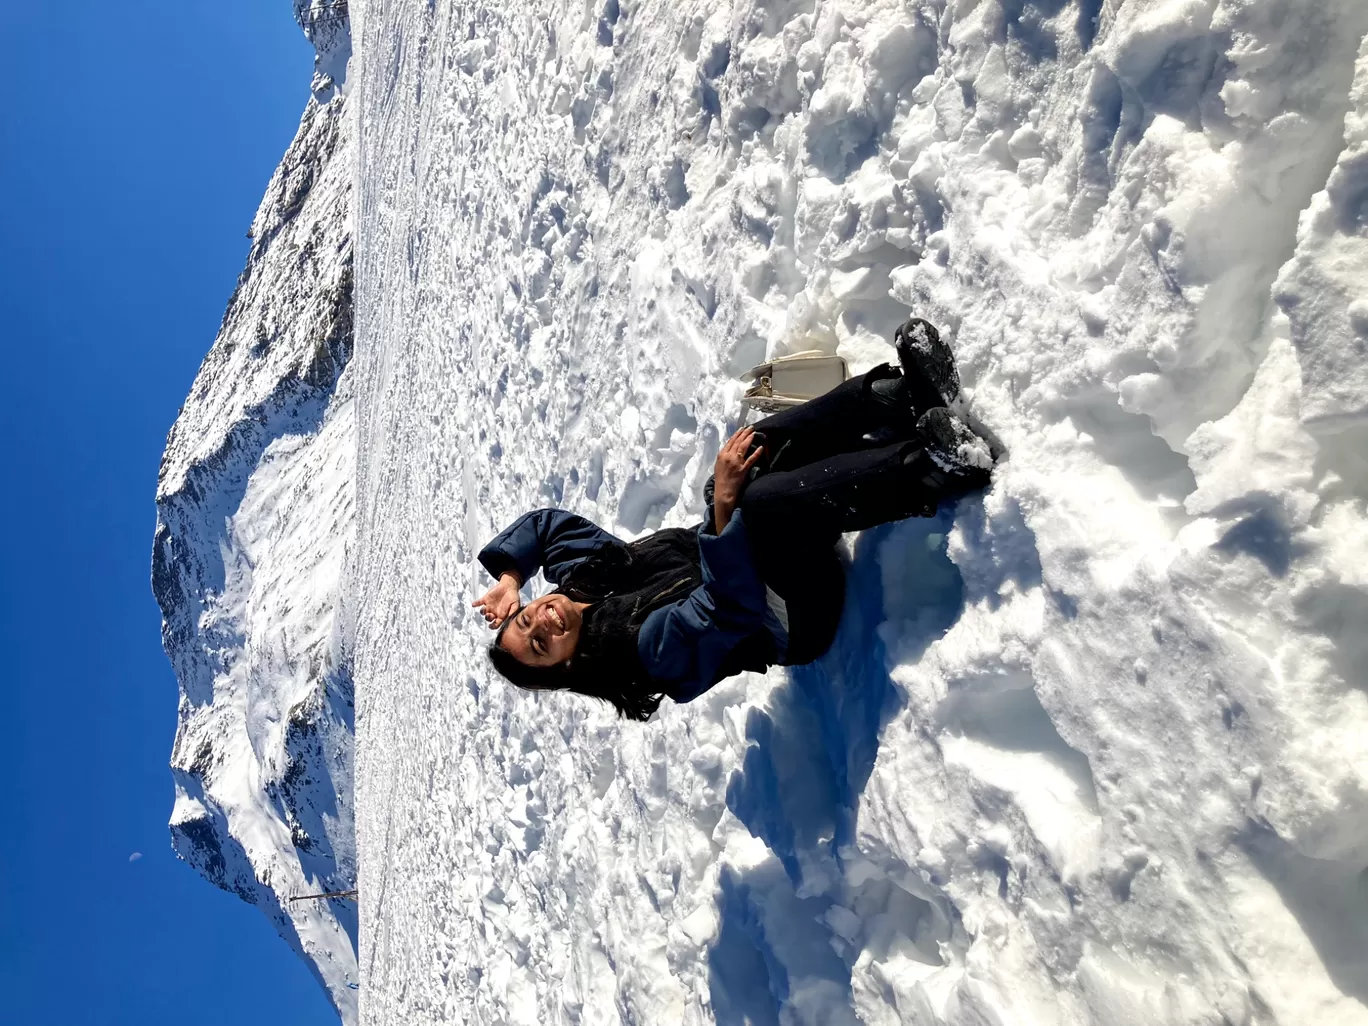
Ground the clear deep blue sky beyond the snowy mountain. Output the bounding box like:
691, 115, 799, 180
0, 0, 337, 1026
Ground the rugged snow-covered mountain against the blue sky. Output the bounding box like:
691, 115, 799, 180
152, 4, 357, 1022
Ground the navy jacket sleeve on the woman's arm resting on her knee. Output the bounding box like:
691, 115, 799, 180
637, 510, 767, 702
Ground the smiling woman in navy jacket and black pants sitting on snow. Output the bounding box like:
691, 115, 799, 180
472, 319, 992, 720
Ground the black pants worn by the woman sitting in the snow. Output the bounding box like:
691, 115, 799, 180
740, 368, 936, 663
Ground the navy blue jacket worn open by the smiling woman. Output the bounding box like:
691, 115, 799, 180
479, 509, 787, 702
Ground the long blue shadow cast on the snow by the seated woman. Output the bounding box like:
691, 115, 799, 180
709, 510, 967, 1026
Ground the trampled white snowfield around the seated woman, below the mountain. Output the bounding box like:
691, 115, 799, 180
353, 0, 1368, 1026
